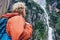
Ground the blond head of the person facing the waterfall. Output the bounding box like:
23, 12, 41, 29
12, 2, 26, 16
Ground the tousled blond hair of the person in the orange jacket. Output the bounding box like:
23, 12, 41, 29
12, 2, 26, 16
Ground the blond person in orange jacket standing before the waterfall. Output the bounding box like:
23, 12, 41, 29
2, 2, 33, 40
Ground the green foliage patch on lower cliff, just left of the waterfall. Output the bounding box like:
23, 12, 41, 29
35, 21, 46, 40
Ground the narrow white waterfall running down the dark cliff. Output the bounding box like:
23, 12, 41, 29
43, 7, 53, 40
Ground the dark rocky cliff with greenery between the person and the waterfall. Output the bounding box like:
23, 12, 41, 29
22, 0, 46, 40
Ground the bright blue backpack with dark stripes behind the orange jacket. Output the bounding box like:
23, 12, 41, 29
0, 18, 11, 40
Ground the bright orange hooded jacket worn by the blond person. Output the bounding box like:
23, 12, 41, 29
3, 13, 32, 40
